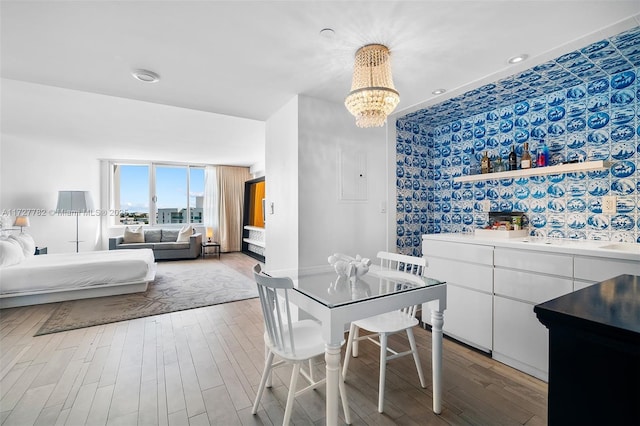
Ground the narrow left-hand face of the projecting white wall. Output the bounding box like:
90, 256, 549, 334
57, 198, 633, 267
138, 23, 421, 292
265, 96, 298, 273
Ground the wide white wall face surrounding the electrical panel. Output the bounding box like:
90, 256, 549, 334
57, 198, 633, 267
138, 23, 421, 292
298, 96, 389, 268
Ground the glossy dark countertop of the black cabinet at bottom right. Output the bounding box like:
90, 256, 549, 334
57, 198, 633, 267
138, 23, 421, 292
533, 275, 640, 343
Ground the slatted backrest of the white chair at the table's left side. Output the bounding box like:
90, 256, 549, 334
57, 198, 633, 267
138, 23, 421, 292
253, 264, 296, 355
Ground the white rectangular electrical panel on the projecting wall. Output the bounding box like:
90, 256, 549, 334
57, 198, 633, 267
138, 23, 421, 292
338, 148, 367, 201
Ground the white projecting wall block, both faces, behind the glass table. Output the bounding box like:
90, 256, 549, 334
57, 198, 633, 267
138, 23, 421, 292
265, 95, 395, 273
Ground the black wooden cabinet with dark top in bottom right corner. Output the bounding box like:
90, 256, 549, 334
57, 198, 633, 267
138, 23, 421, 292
534, 275, 640, 426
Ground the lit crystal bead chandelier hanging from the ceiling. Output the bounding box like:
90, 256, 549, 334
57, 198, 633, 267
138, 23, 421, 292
344, 44, 400, 127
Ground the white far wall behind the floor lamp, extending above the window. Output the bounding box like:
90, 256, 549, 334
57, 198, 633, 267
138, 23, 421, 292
0, 79, 265, 253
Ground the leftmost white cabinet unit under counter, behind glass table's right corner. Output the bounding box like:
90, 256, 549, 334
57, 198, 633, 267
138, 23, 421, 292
422, 241, 493, 352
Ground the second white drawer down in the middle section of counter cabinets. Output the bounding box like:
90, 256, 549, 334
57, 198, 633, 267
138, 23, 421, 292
493, 268, 573, 304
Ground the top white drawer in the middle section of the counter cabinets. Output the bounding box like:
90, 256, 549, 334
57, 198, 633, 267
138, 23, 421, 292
494, 247, 573, 278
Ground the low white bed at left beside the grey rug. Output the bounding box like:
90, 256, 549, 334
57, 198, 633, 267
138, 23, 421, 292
0, 249, 156, 309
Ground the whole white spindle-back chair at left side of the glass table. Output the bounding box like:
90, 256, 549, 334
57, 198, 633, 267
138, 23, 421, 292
252, 264, 351, 425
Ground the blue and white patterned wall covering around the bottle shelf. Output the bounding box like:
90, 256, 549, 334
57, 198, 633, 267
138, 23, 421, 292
396, 27, 640, 256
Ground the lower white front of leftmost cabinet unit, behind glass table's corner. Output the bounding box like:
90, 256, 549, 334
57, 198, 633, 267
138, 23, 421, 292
422, 284, 493, 352
